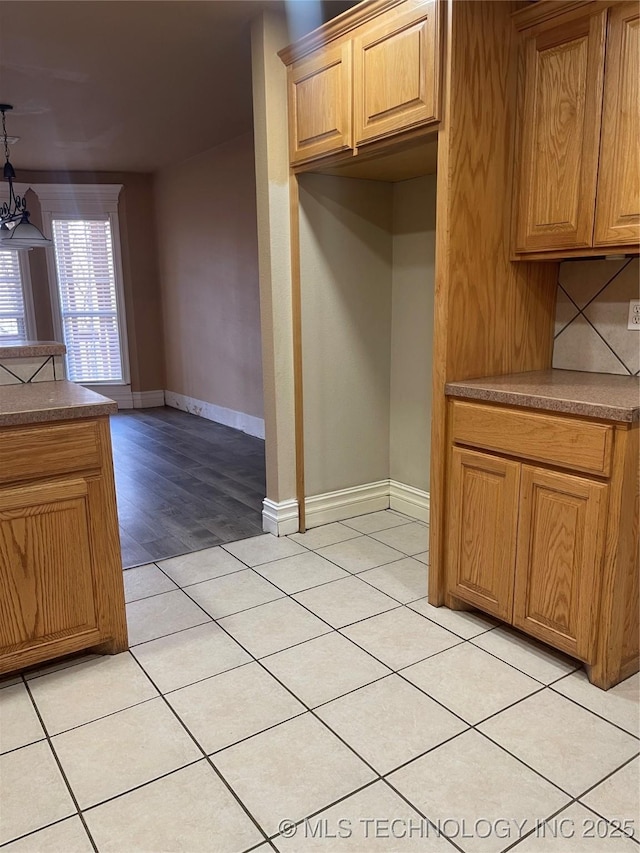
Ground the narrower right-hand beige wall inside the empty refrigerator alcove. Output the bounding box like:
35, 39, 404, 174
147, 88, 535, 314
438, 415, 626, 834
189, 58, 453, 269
389, 175, 436, 491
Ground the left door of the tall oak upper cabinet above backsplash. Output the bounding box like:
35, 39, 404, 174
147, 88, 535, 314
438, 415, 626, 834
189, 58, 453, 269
516, 10, 607, 252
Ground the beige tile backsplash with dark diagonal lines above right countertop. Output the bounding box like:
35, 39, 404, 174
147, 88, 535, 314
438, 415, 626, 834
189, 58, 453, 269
553, 258, 640, 375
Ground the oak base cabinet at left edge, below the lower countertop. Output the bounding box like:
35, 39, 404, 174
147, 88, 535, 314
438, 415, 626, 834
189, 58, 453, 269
0, 417, 127, 673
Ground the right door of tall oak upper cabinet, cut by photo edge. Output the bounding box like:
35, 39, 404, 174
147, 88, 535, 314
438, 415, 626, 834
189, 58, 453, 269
594, 2, 640, 246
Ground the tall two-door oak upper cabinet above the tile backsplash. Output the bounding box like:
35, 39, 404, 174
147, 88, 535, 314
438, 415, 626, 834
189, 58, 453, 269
515, 2, 640, 255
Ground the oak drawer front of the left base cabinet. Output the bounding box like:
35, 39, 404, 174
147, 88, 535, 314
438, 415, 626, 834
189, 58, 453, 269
0, 421, 100, 483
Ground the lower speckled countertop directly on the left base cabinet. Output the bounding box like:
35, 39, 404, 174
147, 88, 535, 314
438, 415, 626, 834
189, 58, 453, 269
0, 379, 118, 427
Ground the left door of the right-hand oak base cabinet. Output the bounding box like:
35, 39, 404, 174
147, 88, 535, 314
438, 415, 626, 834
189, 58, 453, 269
449, 447, 520, 622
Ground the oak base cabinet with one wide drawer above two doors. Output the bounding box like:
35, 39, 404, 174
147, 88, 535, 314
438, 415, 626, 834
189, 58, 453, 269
446, 400, 639, 689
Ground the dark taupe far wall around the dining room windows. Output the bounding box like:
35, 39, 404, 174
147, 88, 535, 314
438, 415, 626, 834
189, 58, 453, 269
19, 172, 165, 391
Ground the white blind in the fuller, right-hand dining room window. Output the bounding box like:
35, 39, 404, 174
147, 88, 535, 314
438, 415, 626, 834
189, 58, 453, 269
52, 218, 123, 383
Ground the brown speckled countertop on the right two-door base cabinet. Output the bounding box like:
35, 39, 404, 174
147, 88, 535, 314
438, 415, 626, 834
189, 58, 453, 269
445, 369, 640, 422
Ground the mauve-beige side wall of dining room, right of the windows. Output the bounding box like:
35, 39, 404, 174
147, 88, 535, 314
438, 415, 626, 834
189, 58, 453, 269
155, 134, 263, 418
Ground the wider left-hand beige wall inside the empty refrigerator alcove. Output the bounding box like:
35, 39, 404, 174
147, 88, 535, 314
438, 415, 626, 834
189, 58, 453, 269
300, 175, 393, 495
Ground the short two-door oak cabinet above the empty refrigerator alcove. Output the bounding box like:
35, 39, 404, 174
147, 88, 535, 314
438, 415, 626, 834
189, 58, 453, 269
280, 0, 440, 165
